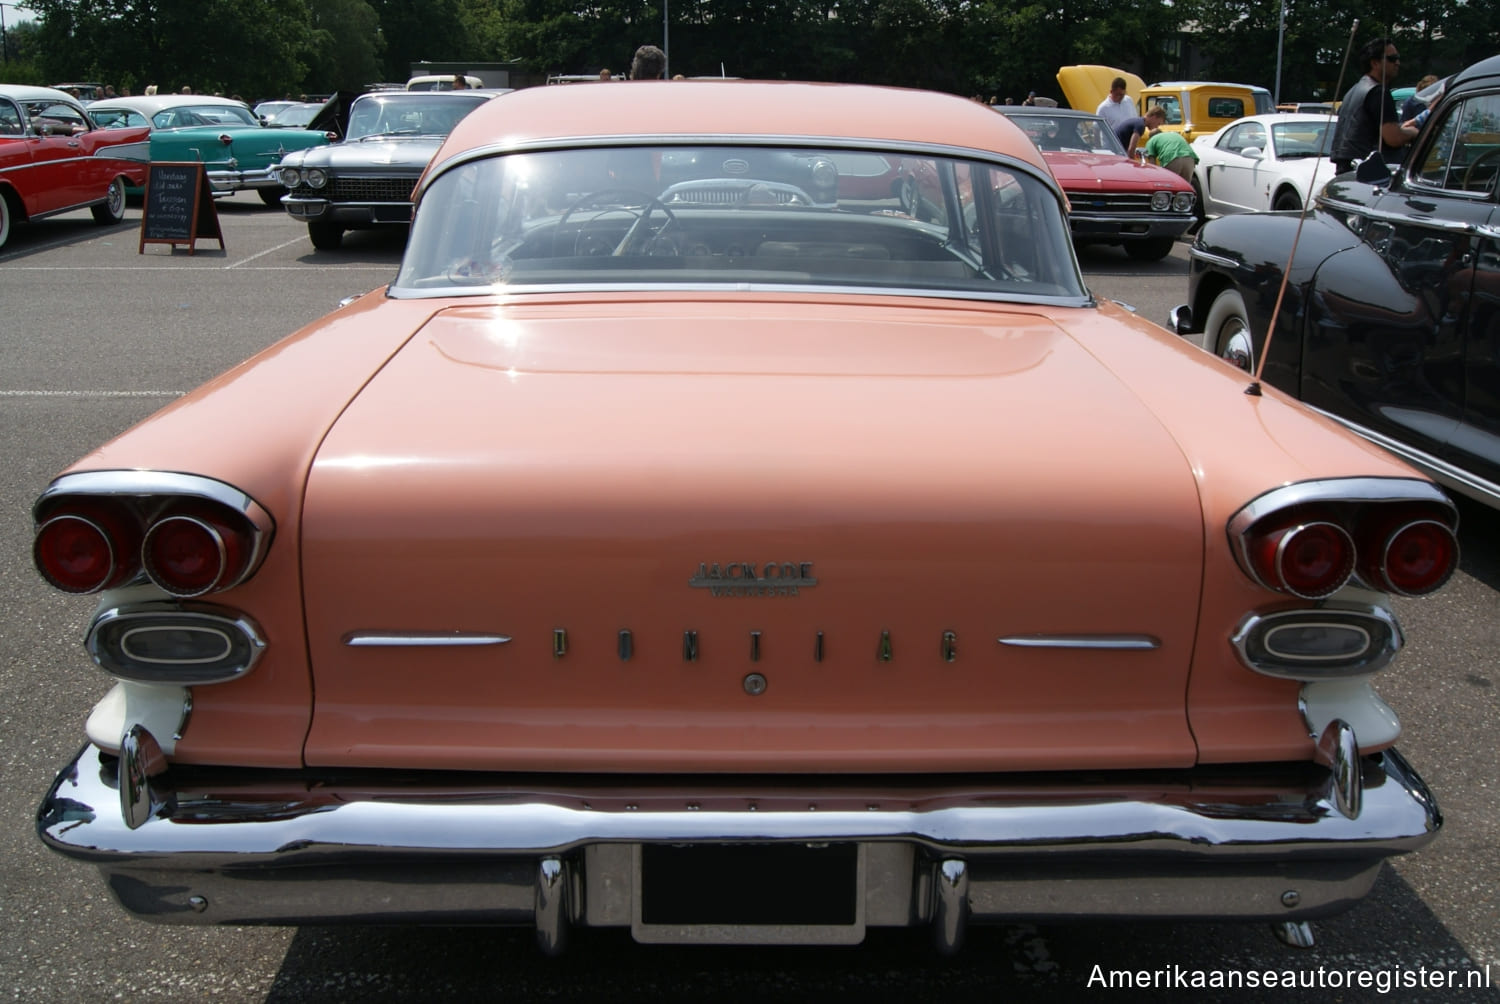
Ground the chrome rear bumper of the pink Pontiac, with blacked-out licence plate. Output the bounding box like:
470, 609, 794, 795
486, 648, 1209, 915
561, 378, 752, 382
38, 729, 1442, 953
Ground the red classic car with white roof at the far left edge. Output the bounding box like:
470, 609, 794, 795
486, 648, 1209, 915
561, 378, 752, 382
0, 84, 149, 248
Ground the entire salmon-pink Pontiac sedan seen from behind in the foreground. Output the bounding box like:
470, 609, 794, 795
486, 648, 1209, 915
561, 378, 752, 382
35, 81, 1457, 951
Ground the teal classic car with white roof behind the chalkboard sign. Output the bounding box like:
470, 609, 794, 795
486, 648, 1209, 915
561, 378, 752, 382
89, 95, 329, 206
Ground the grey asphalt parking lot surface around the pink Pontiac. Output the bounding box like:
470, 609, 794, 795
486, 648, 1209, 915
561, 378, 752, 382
0, 195, 1500, 1002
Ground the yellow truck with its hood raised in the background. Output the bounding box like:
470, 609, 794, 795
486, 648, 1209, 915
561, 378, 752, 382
1058, 65, 1274, 143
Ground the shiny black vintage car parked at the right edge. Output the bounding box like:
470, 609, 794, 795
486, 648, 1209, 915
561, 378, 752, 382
1172, 57, 1500, 506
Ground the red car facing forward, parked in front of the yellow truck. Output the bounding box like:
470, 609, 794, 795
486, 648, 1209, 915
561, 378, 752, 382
996, 105, 1194, 261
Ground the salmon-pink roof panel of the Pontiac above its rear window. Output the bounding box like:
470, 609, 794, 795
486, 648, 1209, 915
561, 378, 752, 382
434, 80, 1047, 174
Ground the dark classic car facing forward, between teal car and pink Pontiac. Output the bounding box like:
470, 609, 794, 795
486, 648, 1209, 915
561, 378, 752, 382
279, 90, 507, 251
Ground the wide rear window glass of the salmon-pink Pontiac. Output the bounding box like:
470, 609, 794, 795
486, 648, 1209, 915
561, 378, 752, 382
393, 146, 1088, 297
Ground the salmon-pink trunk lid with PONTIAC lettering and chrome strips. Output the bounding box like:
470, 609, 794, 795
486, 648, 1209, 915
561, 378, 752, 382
302, 299, 1205, 771
